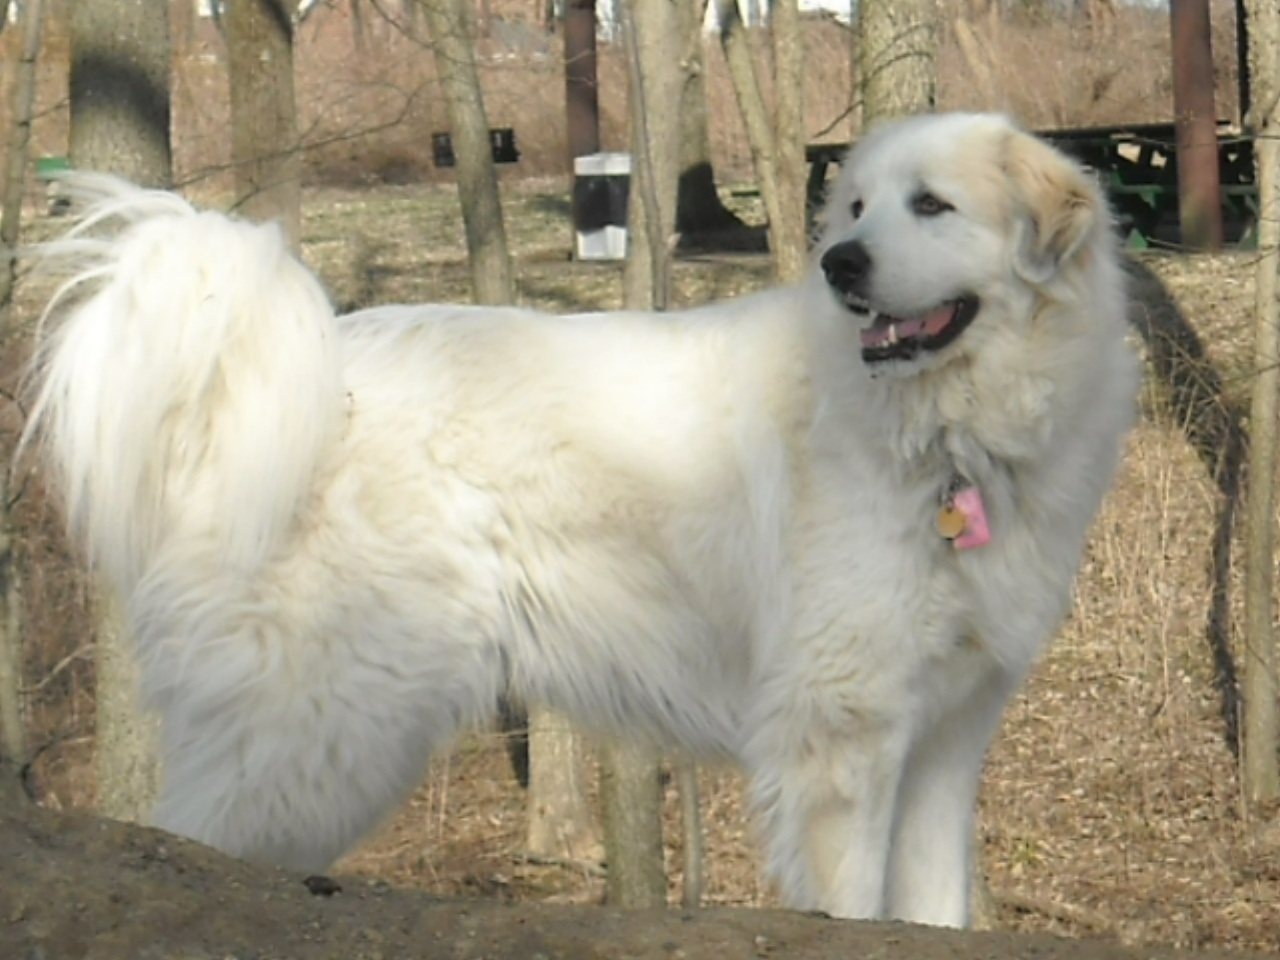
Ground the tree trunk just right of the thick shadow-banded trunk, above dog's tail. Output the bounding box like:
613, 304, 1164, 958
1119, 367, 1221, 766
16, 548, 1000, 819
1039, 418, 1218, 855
223, 0, 302, 250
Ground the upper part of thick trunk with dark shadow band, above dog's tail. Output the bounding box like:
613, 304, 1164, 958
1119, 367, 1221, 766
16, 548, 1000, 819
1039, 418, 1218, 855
70, 0, 173, 187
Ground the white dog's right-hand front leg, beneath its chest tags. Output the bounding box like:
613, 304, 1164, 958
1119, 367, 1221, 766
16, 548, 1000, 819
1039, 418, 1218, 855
887, 676, 1010, 927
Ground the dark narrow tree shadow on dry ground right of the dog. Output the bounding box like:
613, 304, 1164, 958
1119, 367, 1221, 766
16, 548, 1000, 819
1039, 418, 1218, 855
1128, 260, 1248, 753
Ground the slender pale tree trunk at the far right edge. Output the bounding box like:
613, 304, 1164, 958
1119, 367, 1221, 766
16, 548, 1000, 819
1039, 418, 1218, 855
1242, 0, 1280, 805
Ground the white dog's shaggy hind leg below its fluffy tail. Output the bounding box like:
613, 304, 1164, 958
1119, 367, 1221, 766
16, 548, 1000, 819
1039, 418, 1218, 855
143, 593, 502, 872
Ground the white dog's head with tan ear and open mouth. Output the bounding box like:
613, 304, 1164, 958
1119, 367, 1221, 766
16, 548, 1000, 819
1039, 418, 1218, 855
818, 108, 1108, 374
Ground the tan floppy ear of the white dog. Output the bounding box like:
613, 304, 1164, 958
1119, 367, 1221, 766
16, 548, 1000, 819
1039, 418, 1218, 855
1004, 131, 1106, 283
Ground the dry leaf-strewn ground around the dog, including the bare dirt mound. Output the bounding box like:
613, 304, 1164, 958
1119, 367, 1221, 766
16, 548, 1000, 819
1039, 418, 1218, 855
0, 183, 1280, 960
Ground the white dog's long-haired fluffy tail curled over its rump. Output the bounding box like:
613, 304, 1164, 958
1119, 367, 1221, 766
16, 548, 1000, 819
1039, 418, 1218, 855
23, 173, 342, 598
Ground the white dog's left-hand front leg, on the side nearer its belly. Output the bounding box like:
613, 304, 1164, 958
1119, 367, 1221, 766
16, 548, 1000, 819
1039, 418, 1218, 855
753, 724, 909, 919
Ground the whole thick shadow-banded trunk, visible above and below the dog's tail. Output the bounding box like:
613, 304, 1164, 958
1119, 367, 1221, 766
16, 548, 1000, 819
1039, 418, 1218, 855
70, 0, 170, 819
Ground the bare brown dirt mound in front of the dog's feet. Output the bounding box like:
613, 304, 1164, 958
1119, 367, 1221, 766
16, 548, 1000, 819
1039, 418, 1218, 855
0, 806, 1269, 960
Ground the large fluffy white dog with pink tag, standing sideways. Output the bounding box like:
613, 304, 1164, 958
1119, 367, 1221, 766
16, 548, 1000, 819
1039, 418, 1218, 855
27, 114, 1138, 925
